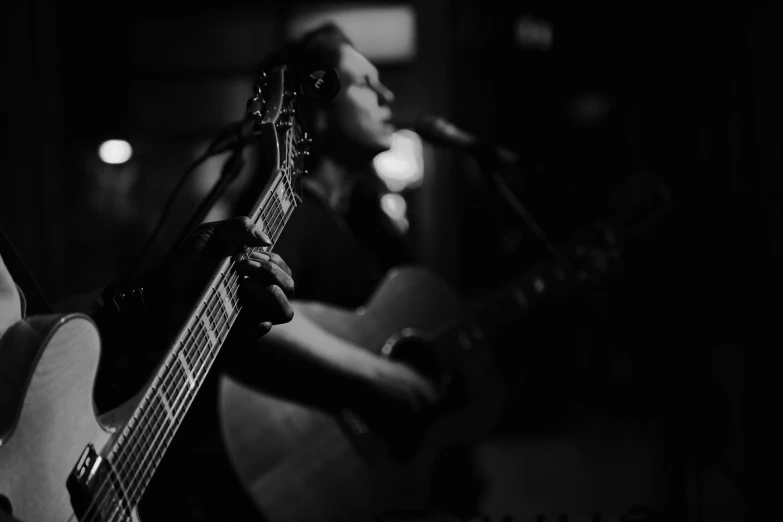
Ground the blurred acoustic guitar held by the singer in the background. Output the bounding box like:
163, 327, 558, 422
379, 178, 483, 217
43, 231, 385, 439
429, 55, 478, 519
219, 170, 666, 522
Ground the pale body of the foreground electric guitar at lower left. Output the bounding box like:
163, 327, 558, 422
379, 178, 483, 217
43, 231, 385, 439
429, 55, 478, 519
0, 314, 137, 522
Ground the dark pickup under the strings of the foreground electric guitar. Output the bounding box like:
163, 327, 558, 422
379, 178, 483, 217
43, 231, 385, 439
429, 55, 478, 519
65, 444, 132, 522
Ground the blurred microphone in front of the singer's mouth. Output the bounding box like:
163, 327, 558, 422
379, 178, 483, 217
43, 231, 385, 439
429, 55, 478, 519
393, 115, 519, 165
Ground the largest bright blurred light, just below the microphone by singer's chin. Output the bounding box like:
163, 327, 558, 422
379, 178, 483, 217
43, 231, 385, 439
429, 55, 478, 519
373, 130, 424, 192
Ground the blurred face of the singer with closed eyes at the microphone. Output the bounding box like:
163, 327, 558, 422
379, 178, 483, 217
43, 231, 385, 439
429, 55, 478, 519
327, 44, 394, 155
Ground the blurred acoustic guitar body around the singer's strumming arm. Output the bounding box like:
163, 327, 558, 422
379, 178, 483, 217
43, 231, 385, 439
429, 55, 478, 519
219, 267, 502, 521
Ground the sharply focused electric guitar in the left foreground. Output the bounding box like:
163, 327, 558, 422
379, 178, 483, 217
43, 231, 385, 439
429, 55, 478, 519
0, 67, 310, 522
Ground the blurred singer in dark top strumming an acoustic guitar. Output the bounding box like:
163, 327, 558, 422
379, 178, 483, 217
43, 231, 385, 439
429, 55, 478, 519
224, 23, 484, 516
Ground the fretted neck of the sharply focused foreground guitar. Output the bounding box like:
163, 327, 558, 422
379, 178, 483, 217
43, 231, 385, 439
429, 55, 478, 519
108, 171, 296, 506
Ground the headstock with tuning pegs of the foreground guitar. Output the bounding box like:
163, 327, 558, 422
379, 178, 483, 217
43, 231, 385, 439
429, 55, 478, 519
247, 65, 312, 200
